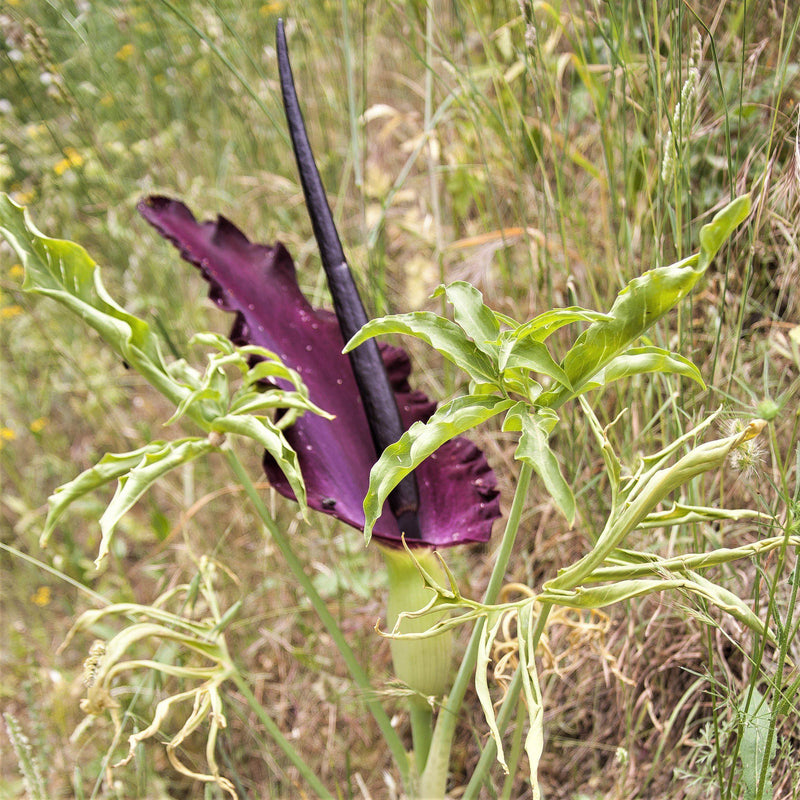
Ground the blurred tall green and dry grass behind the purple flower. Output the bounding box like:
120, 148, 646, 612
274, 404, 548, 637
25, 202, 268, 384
0, 0, 800, 798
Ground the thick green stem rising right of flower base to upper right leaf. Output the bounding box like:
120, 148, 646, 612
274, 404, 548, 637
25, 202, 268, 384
419, 462, 538, 798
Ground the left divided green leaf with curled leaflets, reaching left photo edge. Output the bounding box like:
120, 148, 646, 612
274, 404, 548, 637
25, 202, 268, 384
0, 194, 331, 565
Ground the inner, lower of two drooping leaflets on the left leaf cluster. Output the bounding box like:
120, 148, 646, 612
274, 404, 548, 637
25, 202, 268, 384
94, 436, 215, 567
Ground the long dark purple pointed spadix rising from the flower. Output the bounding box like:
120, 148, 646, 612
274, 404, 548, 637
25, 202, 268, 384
276, 20, 419, 538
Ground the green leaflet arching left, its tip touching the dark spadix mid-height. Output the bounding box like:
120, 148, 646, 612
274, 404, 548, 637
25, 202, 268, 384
344, 311, 498, 385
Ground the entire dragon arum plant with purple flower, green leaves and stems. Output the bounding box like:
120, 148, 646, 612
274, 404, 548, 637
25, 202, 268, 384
0, 17, 800, 798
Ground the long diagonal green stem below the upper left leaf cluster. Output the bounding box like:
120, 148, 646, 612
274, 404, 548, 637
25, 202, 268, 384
223, 446, 411, 786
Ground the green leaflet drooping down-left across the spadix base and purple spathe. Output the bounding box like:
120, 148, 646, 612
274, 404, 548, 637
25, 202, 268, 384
364, 395, 515, 542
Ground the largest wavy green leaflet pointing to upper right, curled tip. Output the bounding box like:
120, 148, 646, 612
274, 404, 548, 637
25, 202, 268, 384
536, 196, 750, 408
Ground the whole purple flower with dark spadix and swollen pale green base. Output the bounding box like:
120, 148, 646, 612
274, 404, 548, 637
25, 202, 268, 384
139, 20, 500, 752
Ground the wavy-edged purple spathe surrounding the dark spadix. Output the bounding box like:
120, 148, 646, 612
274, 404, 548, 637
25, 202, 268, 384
139, 197, 500, 547
